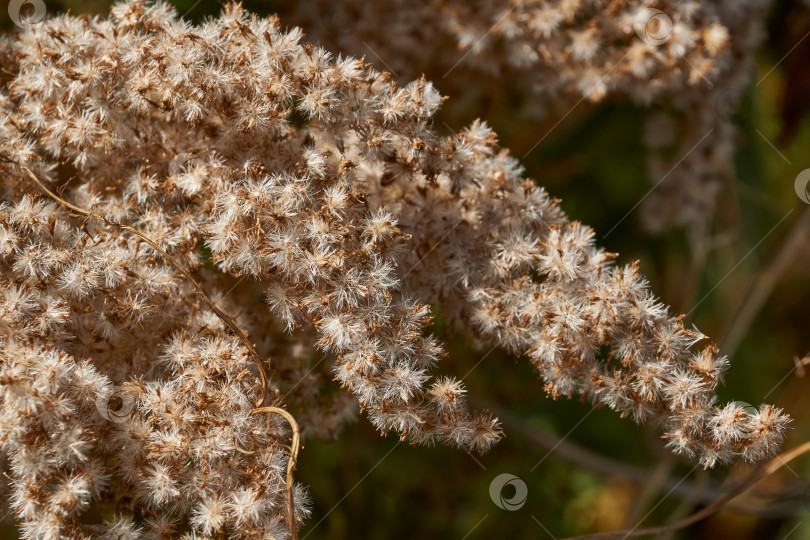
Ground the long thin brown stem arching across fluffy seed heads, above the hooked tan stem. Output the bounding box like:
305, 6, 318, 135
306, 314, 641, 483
20, 165, 267, 407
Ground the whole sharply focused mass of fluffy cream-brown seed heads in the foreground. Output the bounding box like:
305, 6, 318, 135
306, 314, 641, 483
0, 0, 787, 538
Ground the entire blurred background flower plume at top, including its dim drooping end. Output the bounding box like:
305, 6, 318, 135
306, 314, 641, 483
290, 0, 770, 231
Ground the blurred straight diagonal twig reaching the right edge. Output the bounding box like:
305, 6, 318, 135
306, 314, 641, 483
720, 208, 810, 358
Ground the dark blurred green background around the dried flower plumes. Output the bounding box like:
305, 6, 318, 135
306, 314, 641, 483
0, 0, 810, 540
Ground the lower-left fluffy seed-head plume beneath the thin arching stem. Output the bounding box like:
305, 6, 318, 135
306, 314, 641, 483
0, 196, 304, 538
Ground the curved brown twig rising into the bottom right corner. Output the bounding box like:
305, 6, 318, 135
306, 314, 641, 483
564, 442, 810, 540
